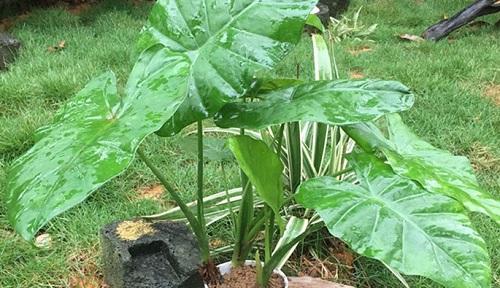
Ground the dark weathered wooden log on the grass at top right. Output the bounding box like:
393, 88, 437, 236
423, 0, 500, 41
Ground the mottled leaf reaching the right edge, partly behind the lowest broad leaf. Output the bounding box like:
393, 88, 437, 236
345, 114, 500, 223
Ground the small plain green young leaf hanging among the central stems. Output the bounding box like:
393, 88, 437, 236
228, 136, 284, 218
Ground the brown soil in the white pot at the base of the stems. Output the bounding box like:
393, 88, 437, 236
210, 266, 285, 288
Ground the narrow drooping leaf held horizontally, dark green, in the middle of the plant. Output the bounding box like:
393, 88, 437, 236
215, 80, 413, 129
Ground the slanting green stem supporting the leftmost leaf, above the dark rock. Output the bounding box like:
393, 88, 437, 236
137, 147, 210, 263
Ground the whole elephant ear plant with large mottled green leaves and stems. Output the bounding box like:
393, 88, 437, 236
7, 0, 500, 287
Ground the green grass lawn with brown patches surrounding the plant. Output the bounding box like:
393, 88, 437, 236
0, 0, 500, 287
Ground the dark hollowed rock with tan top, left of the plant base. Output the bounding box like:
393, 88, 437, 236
101, 220, 204, 288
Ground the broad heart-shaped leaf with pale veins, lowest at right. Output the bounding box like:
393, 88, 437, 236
296, 153, 491, 288
